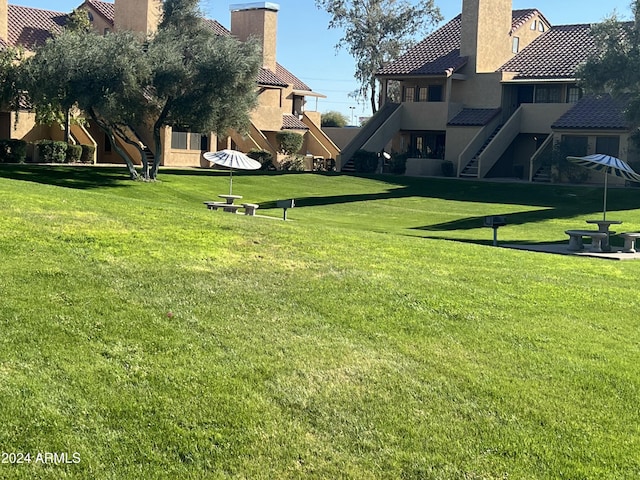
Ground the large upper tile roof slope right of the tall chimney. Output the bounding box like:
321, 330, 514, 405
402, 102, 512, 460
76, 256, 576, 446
499, 25, 595, 79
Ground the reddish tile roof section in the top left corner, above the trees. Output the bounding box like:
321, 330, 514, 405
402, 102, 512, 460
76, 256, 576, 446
8, 5, 67, 48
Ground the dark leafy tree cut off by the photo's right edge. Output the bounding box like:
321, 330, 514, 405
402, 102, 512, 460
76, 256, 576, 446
578, 0, 640, 143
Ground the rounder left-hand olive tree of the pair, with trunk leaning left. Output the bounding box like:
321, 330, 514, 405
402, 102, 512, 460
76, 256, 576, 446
25, 30, 151, 178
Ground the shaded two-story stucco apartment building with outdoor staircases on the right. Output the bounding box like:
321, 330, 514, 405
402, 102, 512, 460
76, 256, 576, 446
341, 0, 630, 180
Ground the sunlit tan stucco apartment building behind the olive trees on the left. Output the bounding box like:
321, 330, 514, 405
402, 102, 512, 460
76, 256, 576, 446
0, 0, 339, 166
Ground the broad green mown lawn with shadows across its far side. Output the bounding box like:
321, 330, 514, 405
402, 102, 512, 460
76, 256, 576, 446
0, 166, 640, 480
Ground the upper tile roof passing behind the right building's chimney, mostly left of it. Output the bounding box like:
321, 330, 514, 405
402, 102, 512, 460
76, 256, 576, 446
377, 9, 539, 76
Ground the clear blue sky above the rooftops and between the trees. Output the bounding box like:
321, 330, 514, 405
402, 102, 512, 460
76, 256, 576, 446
9, 0, 632, 125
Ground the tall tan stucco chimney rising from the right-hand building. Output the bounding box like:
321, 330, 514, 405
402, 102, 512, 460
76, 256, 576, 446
460, 0, 513, 73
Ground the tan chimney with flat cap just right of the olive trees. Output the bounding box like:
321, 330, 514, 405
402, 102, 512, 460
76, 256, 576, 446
229, 2, 280, 72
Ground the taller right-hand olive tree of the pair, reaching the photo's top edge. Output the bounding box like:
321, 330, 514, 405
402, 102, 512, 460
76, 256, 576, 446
147, 0, 261, 178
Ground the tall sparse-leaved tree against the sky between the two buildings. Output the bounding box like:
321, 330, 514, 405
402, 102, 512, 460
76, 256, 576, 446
316, 0, 442, 113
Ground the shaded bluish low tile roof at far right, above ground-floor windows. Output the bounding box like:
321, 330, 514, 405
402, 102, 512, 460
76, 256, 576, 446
551, 95, 630, 130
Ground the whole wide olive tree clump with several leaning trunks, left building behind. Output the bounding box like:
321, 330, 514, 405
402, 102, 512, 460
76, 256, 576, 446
26, 0, 260, 179
